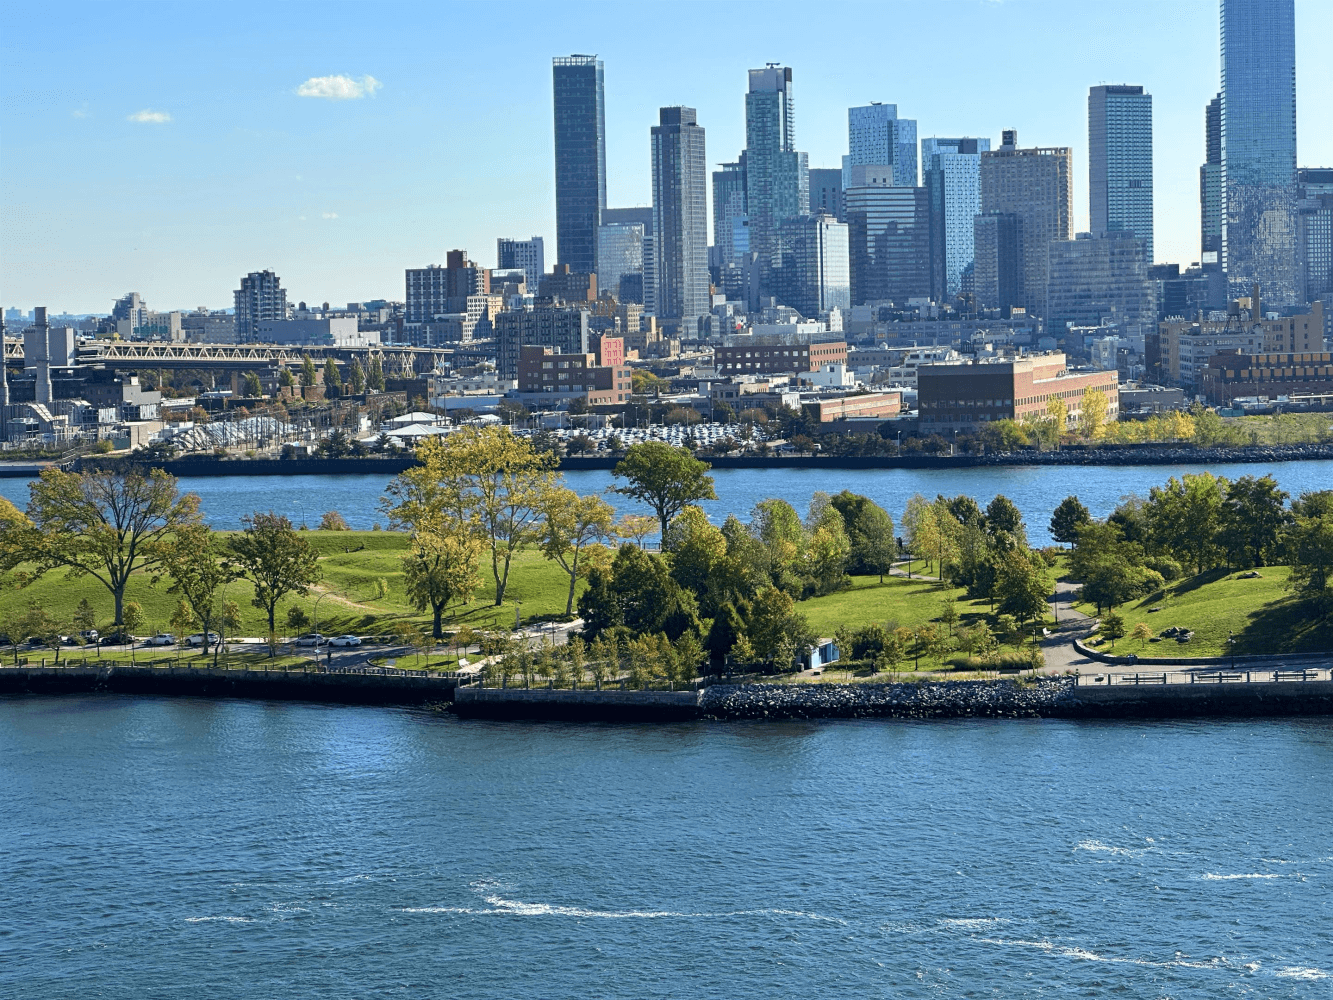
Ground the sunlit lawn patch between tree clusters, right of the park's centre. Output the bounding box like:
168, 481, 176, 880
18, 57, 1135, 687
796, 576, 990, 636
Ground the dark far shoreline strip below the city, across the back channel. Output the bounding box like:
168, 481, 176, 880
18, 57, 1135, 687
0, 444, 1333, 479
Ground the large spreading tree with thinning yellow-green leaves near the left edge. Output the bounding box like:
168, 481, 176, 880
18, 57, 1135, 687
18, 469, 199, 625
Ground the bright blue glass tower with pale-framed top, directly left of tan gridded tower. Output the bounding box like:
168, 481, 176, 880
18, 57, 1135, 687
921, 137, 990, 301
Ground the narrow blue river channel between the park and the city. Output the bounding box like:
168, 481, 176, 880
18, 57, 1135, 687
0, 460, 1333, 545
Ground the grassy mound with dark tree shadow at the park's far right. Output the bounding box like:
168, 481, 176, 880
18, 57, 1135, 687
1078, 565, 1333, 656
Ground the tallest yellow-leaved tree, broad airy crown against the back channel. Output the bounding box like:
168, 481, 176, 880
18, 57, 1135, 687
380, 427, 556, 607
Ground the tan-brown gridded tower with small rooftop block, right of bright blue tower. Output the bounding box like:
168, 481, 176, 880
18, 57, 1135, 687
981, 129, 1073, 315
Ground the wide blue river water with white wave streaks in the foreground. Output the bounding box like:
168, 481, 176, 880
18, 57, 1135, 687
0, 696, 1333, 1000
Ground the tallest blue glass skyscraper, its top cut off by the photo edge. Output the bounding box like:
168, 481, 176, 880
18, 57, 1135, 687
1221, 0, 1301, 305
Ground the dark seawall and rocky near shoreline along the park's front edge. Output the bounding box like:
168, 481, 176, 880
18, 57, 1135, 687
0, 667, 1333, 723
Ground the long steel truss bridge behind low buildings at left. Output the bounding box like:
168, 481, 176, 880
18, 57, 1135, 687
4, 337, 495, 377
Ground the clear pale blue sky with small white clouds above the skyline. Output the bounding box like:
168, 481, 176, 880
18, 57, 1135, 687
0, 0, 1333, 313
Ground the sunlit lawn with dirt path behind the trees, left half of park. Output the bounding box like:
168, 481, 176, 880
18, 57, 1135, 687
0, 531, 587, 636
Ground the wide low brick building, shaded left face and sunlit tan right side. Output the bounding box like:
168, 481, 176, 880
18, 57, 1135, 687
917, 353, 1120, 433
